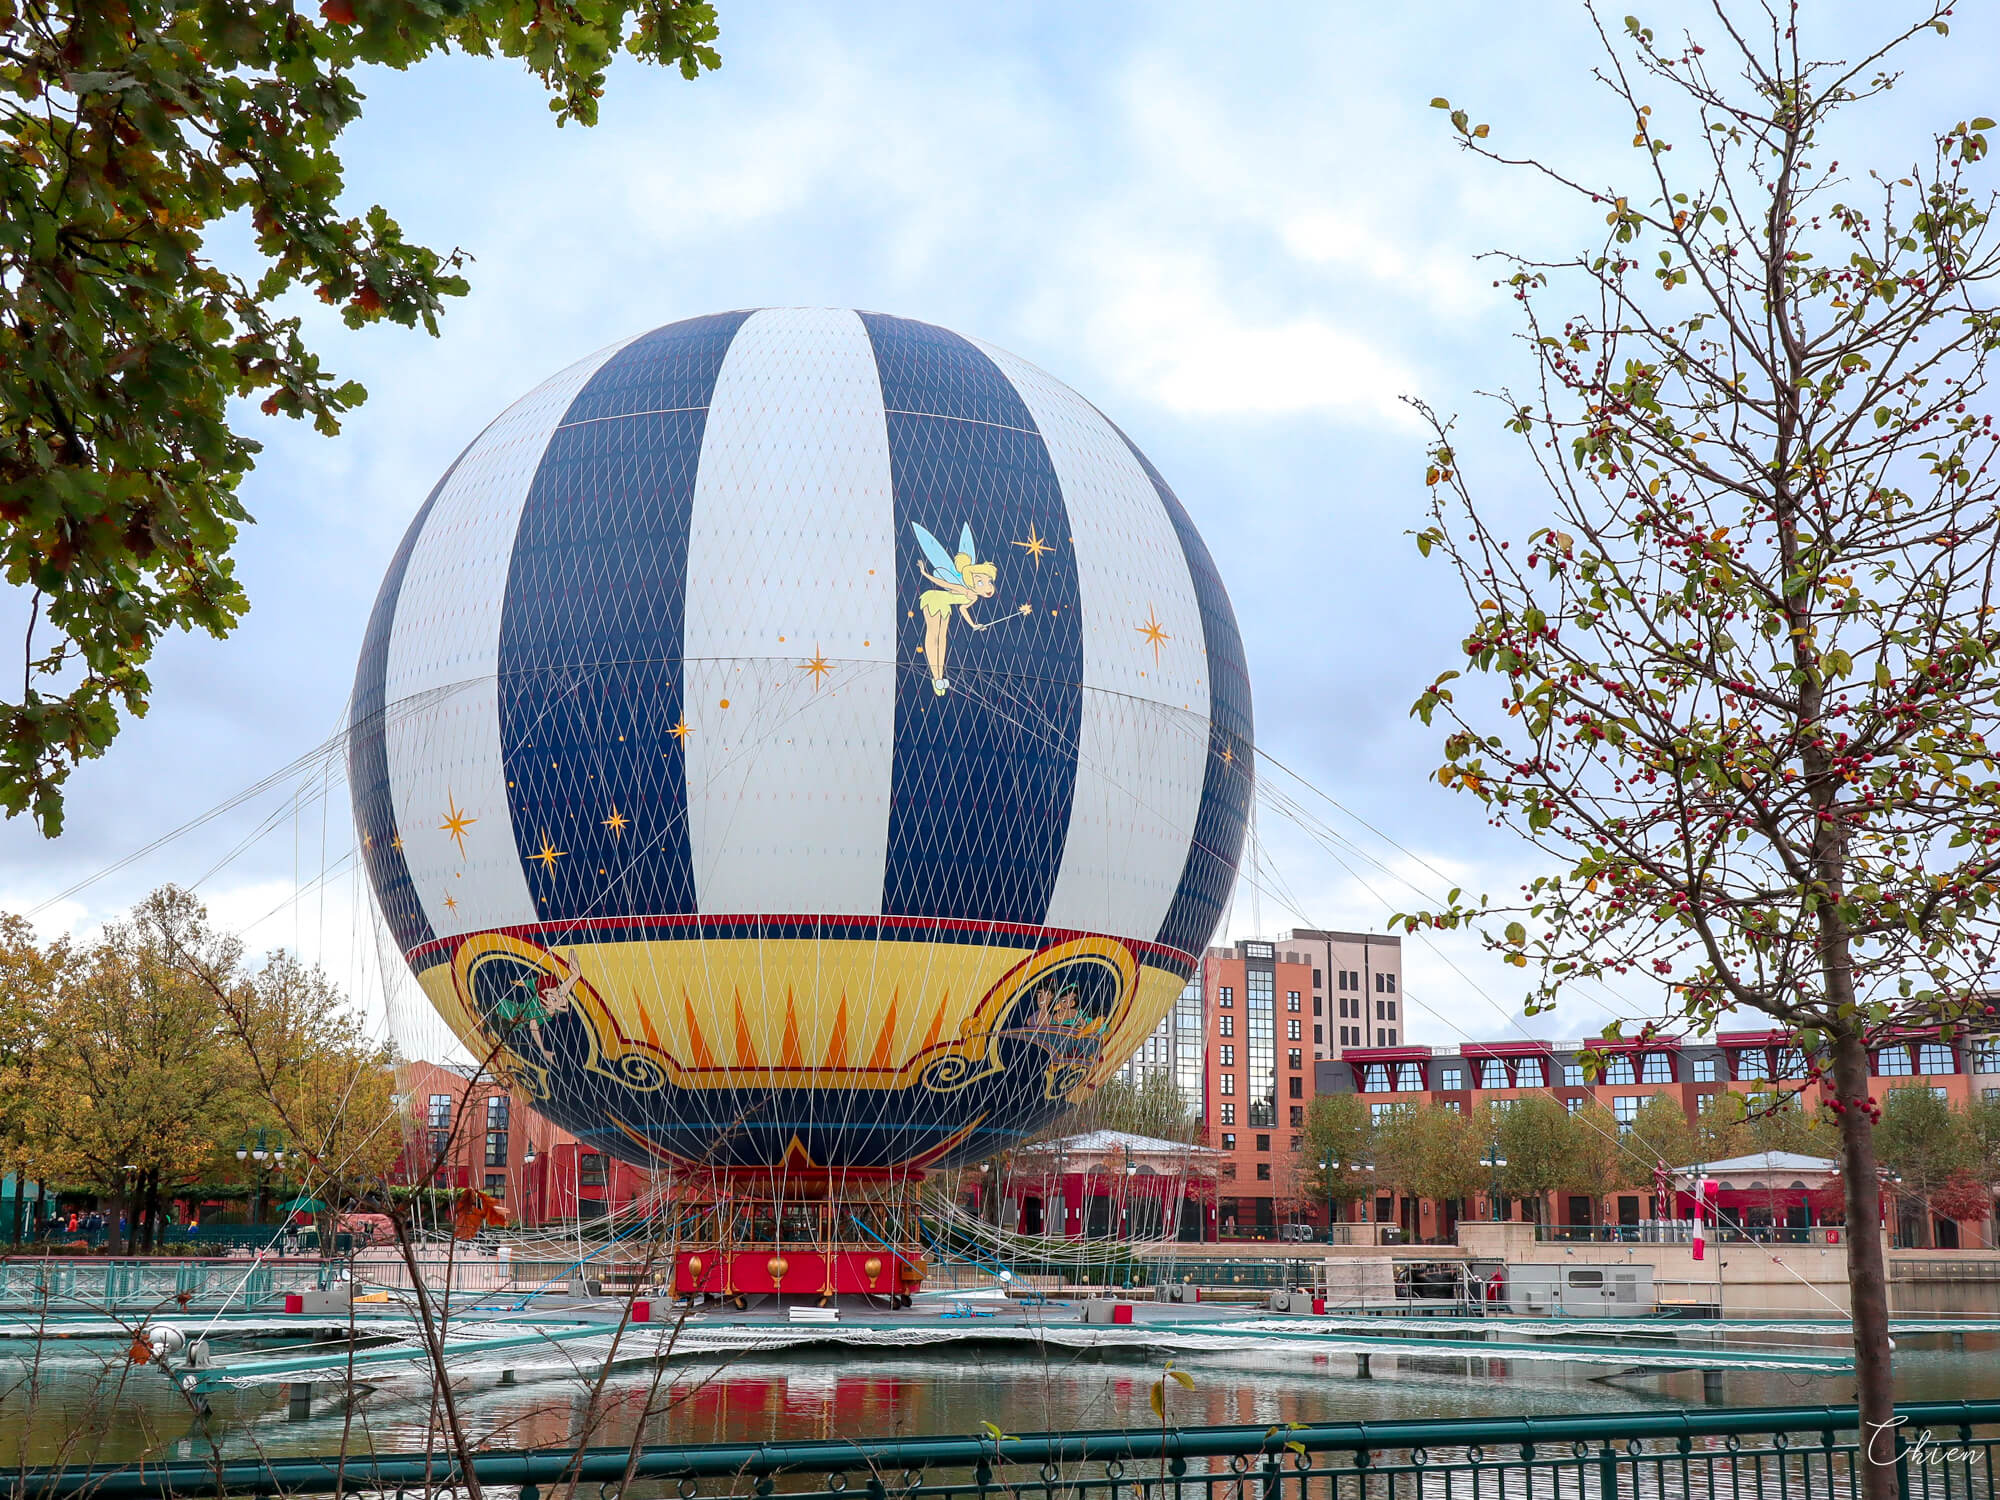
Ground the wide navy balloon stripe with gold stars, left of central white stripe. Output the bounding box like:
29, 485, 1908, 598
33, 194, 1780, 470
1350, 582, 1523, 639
500, 312, 750, 922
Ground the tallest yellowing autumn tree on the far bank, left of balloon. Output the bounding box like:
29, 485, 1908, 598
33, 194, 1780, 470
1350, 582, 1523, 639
24, 888, 248, 1254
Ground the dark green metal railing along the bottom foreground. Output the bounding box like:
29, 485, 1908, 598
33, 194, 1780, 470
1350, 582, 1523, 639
0, 1402, 2000, 1500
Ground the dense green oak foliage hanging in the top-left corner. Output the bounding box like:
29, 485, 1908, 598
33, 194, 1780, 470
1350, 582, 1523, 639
0, 0, 718, 836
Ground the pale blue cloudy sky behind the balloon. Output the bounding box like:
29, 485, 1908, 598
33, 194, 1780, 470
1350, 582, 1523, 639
0, 0, 2000, 1044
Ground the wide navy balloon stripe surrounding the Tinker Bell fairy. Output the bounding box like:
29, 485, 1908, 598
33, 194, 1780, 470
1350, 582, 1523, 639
860, 312, 1084, 924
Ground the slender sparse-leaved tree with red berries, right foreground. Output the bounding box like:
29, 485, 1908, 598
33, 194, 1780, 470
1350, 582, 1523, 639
1406, 4, 2000, 1472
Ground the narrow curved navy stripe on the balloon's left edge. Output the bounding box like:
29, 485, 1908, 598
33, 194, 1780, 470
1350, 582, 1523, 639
348, 452, 466, 954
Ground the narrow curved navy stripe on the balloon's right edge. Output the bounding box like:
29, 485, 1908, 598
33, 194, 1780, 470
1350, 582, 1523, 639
1118, 432, 1256, 954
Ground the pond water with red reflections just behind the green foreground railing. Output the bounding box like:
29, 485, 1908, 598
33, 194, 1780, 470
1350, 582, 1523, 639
11, 1334, 2000, 1464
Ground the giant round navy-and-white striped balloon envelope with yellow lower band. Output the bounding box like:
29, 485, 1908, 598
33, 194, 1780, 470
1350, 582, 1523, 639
350, 308, 1252, 1172
